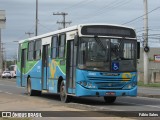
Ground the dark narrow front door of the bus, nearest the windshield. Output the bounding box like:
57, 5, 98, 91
66, 40, 77, 94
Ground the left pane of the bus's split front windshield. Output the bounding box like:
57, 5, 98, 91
78, 37, 110, 71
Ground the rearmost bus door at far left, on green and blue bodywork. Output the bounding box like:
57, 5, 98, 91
20, 49, 27, 87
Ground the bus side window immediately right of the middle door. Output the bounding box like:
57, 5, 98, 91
51, 36, 58, 58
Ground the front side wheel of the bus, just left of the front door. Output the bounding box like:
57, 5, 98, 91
60, 80, 71, 103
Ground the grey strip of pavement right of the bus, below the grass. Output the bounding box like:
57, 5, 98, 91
138, 87, 160, 98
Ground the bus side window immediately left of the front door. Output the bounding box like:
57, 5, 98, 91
58, 34, 66, 58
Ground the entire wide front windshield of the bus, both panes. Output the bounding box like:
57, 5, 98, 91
78, 37, 136, 71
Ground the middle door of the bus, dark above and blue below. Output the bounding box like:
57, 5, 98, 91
42, 45, 49, 90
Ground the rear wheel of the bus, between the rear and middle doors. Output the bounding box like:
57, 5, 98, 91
27, 77, 41, 96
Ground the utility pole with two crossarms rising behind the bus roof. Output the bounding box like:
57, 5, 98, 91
53, 12, 72, 28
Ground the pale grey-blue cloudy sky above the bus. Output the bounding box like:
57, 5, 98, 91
0, 0, 160, 59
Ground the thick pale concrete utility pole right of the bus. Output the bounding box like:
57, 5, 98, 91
143, 0, 149, 84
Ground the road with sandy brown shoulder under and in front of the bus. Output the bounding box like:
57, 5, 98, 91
0, 79, 160, 119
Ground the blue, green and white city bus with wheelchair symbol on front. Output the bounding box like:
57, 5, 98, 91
16, 24, 140, 103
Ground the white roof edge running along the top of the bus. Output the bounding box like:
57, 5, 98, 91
19, 23, 134, 43
